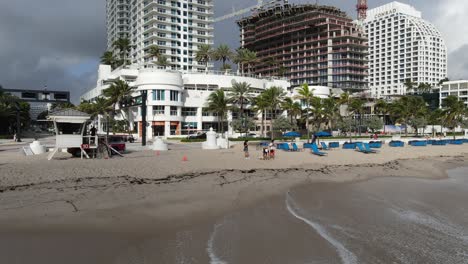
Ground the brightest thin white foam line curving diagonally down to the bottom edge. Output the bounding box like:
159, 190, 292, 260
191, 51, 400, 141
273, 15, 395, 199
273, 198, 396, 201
286, 192, 357, 264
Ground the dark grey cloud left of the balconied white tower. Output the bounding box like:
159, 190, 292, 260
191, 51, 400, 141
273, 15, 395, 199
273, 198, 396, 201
0, 0, 105, 101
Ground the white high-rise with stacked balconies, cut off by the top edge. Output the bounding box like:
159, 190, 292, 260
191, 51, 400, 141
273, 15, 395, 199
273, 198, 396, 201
107, 0, 214, 71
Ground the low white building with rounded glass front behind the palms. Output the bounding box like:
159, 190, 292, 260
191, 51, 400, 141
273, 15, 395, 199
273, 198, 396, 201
81, 65, 290, 138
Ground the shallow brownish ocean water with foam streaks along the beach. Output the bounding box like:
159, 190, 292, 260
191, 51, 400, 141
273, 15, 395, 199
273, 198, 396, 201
0, 168, 468, 264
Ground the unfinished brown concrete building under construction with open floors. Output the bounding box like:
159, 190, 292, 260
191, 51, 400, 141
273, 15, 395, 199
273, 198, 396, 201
237, 1, 368, 90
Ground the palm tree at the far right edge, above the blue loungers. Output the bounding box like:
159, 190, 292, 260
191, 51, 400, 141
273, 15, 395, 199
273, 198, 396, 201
442, 95, 468, 139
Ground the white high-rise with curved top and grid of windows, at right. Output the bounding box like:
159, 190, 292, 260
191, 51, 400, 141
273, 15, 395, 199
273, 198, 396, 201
364, 2, 447, 97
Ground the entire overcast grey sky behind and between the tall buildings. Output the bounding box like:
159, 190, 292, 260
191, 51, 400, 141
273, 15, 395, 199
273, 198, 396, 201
0, 0, 468, 102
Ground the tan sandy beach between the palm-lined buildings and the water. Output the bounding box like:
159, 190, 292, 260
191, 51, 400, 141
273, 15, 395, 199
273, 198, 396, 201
0, 145, 468, 263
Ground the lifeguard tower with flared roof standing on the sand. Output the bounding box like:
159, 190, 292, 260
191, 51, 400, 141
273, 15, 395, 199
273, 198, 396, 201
47, 109, 93, 160
